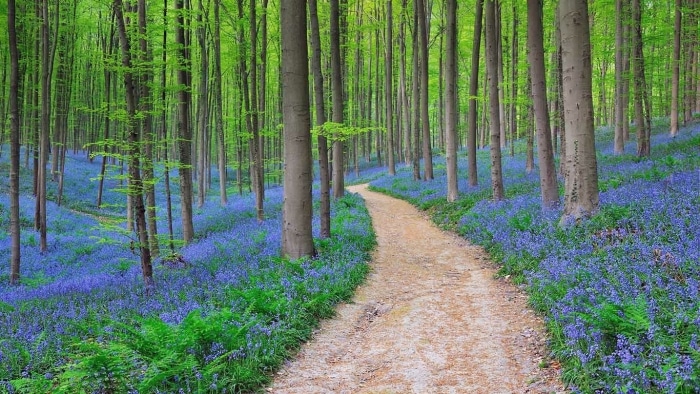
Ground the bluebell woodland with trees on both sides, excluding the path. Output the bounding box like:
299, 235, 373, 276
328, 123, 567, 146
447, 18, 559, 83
0, 0, 700, 393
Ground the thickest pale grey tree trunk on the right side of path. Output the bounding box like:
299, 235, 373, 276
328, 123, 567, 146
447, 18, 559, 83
559, 0, 598, 224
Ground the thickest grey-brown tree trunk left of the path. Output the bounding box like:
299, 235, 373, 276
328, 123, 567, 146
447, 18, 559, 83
281, 0, 314, 259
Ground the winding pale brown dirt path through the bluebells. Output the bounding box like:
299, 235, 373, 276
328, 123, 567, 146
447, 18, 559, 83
268, 185, 563, 394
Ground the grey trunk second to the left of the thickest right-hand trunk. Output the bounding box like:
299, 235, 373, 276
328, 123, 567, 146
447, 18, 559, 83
484, 0, 504, 201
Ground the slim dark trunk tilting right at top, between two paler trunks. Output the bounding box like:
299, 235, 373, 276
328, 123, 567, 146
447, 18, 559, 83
467, 0, 484, 186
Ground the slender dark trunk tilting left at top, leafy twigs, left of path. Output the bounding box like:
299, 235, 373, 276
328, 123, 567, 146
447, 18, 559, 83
114, 0, 155, 294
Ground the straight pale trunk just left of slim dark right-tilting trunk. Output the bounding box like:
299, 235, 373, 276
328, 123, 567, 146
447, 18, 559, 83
445, 0, 459, 202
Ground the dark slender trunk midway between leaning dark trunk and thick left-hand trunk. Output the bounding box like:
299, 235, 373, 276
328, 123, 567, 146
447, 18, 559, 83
175, 0, 194, 244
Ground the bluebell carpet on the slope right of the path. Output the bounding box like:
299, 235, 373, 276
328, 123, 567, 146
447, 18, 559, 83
371, 124, 700, 394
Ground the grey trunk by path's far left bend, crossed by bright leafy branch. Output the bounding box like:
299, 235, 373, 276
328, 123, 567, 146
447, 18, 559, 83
330, 0, 345, 198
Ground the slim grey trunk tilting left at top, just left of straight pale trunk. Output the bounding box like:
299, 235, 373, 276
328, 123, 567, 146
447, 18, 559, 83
414, 0, 433, 181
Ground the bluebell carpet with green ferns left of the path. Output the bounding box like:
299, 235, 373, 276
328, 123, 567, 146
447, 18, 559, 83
0, 149, 375, 393
